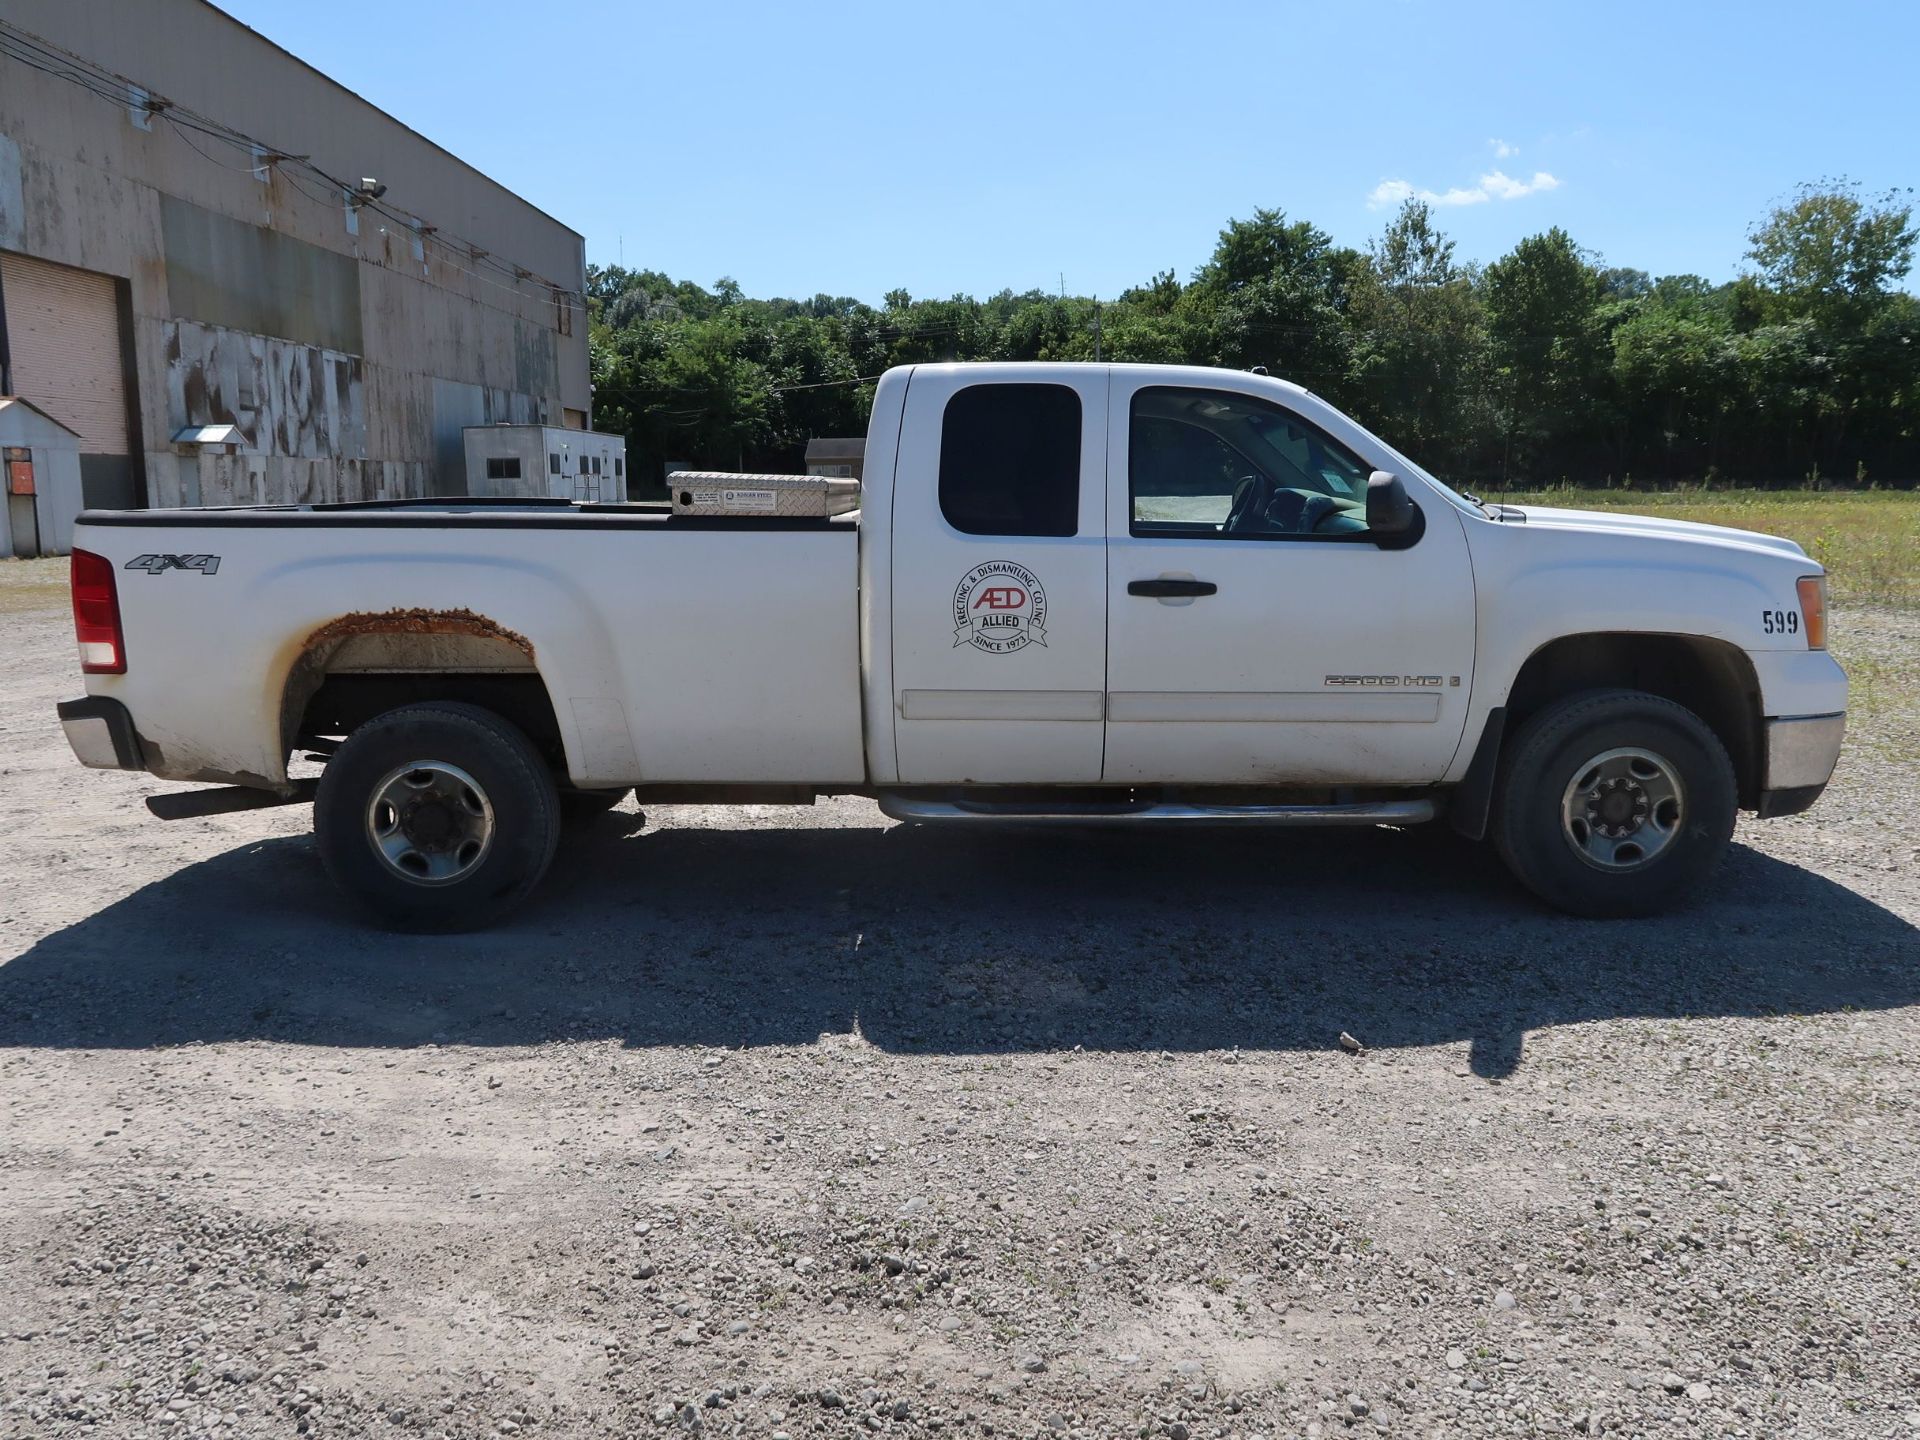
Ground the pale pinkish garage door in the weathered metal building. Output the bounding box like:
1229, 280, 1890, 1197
0, 255, 127, 455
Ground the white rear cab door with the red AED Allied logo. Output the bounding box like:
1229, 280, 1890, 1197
893, 365, 1108, 785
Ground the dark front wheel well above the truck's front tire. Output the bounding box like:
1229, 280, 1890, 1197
1507, 634, 1764, 810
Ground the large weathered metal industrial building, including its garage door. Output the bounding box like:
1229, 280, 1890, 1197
0, 0, 589, 518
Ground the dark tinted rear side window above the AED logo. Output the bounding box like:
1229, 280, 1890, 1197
941, 384, 1081, 536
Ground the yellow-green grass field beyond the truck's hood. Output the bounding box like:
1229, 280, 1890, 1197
1490, 490, 1920, 609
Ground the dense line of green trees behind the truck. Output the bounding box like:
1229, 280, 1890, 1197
588, 180, 1920, 490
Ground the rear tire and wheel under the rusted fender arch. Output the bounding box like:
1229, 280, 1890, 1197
313, 701, 561, 931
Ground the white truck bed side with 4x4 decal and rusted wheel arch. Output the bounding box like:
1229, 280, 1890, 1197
75, 499, 866, 787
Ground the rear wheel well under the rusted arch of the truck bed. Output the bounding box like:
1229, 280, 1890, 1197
280, 611, 566, 774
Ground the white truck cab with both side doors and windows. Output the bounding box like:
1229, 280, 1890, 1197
866, 365, 1475, 787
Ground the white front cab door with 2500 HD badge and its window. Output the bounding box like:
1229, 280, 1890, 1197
1104, 378, 1475, 785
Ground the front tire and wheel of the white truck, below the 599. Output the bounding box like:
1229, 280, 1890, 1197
1492, 689, 1738, 920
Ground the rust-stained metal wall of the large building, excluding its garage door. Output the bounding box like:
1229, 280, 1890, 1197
0, 0, 589, 505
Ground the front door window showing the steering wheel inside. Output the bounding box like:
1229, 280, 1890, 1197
1127, 386, 1371, 540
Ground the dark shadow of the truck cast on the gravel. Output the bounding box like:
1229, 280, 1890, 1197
0, 812, 1920, 1077
